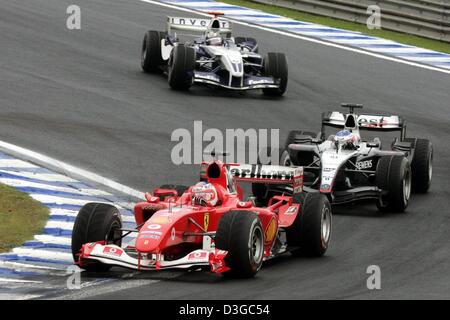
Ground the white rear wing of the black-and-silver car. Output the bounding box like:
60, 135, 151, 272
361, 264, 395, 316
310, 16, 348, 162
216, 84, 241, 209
322, 111, 406, 138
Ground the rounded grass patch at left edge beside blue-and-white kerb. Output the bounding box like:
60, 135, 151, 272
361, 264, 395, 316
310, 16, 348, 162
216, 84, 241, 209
0, 184, 49, 252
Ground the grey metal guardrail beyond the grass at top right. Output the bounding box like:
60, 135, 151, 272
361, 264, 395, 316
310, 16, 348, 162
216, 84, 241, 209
251, 0, 450, 42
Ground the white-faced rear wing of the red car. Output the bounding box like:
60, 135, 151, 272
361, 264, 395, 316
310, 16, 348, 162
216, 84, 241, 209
230, 164, 303, 193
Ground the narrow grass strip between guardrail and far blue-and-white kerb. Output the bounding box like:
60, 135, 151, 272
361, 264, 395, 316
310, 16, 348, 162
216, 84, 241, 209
220, 0, 450, 53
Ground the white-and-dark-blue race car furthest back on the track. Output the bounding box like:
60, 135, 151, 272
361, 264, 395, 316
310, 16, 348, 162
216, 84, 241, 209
141, 13, 288, 96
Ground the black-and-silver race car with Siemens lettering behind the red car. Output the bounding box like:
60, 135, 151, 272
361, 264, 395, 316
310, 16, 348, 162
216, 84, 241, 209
253, 104, 433, 212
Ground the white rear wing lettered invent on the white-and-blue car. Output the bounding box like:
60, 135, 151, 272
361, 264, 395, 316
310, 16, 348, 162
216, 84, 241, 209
167, 17, 233, 38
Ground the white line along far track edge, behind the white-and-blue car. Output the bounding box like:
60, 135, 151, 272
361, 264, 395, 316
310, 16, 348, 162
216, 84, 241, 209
139, 0, 450, 74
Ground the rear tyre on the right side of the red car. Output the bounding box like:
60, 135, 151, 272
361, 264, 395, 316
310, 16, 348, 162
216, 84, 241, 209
286, 193, 332, 257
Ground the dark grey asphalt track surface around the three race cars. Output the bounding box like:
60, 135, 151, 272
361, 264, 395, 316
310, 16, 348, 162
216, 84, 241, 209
0, 0, 450, 299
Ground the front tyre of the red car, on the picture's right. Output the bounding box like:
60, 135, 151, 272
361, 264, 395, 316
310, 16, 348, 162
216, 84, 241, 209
214, 210, 264, 278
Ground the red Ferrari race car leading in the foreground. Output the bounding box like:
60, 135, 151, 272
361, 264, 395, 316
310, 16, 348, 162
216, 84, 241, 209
72, 160, 331, 277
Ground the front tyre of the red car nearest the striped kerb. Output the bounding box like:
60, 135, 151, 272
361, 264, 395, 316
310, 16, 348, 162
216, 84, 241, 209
72, 203, 122, 272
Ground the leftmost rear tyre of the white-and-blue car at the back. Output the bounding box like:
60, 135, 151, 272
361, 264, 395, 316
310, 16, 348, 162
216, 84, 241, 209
141, 30, 167, 73
